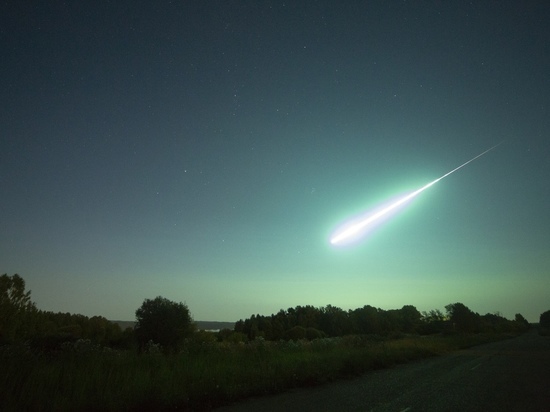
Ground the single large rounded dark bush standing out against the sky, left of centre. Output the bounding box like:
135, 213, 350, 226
135, 296, 195, 352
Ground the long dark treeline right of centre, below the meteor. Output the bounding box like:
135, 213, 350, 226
235, 303, 529, 340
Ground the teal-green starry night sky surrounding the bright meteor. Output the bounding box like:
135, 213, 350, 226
0, 0, 550, 322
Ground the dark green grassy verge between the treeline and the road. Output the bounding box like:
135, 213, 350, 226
0, 334, 510, 411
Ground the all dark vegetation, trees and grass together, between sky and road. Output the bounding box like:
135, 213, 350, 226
0, 275, 548, 411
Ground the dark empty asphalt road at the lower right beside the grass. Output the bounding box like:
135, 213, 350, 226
217, 329, 550, 412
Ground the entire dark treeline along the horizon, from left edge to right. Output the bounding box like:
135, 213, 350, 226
0, 274, 540, 353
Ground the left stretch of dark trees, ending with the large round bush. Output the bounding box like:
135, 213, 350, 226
0, 274, 209, 353
